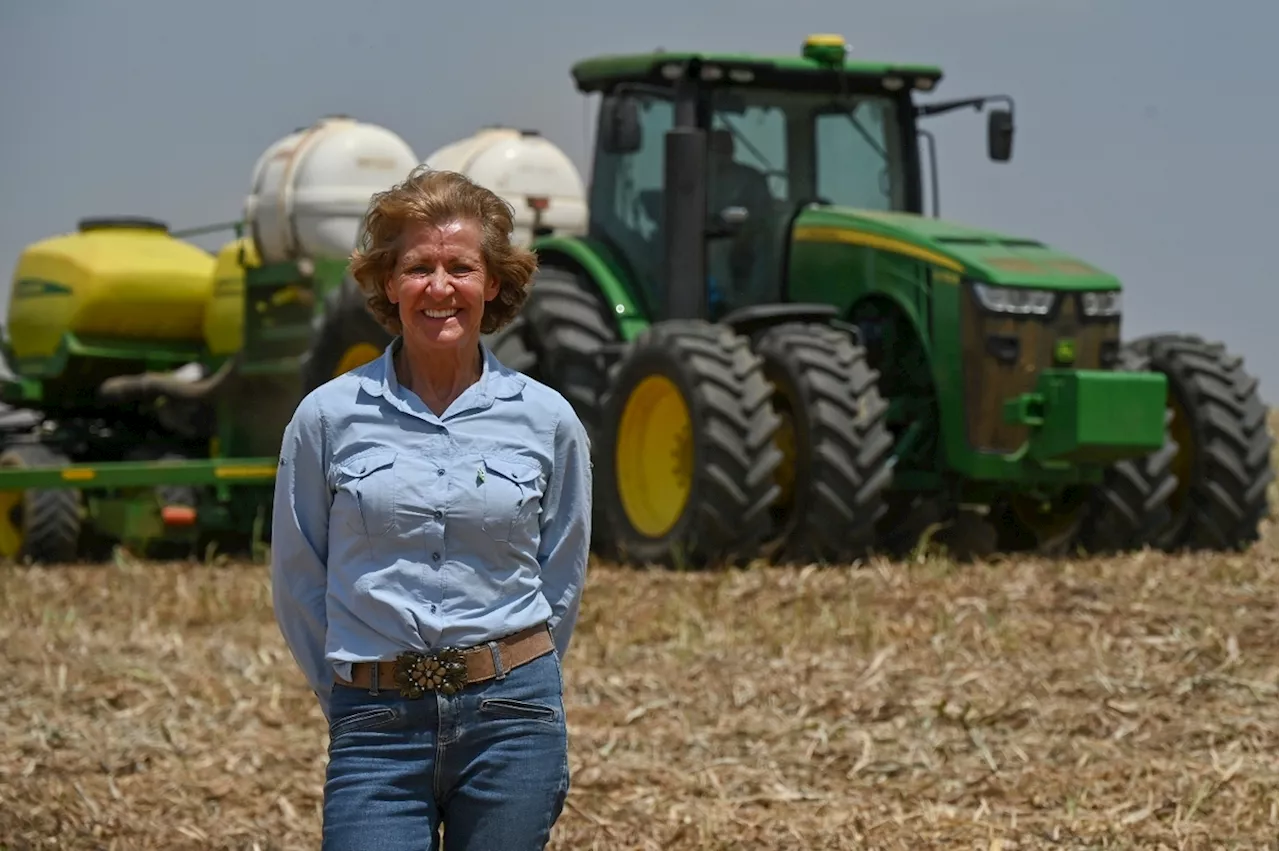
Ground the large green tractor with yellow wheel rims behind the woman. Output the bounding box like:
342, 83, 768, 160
492, 36, 1272, 564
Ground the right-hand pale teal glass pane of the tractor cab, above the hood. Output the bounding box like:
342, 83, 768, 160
814, 99, 905, 210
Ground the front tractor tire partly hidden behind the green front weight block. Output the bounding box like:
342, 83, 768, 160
1078, 346, 1178, 555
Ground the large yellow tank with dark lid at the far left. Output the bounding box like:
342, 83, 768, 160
9, 218, 215, 358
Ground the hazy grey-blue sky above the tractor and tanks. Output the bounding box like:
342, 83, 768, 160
0, 0, 1280, 402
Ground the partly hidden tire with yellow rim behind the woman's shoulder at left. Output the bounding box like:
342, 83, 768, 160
302, 276, 392, 395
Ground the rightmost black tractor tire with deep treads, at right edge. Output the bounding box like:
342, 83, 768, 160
1130, 334, 1275, 552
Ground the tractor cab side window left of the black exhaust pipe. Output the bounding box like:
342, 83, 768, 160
590, 91, 675, 311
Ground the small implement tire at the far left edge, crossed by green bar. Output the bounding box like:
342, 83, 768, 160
0, 443, 81, 564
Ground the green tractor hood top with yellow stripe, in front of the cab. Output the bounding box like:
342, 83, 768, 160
796, 207, 1120, 290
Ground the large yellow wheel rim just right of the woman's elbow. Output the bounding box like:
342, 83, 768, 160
614, 375, 694, 537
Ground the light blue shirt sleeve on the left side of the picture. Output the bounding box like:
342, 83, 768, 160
271, 397, 333, 720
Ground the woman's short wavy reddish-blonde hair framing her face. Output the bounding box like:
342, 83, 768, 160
351, 166, 538, 334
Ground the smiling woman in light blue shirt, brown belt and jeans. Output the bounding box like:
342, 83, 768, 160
271, 162, 591, 851
